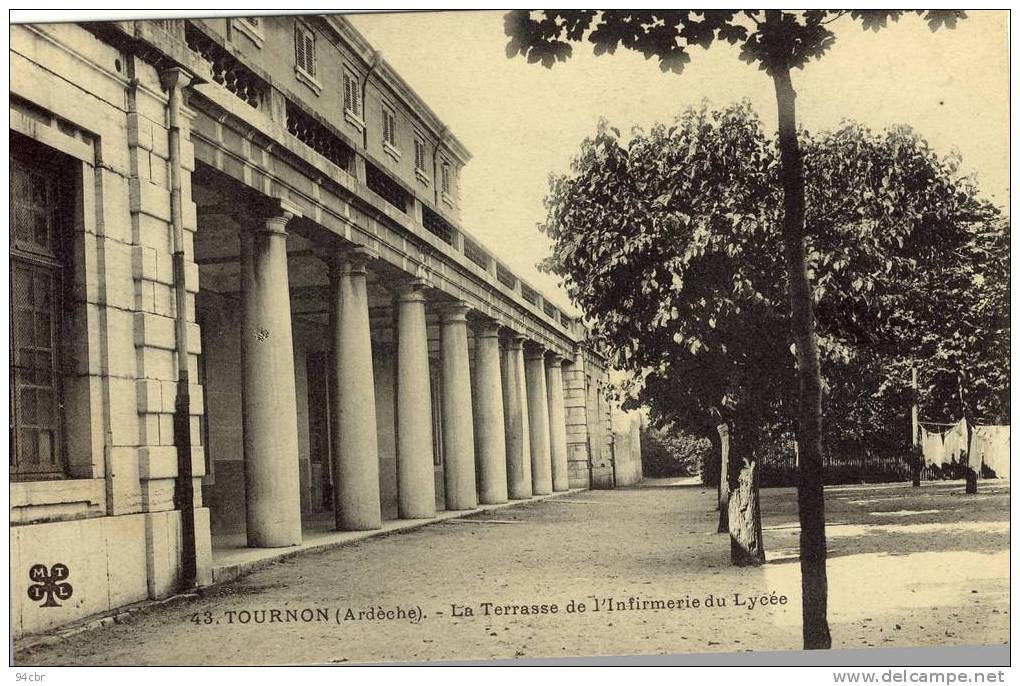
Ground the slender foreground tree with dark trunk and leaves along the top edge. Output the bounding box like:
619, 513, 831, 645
505, 9, 964, 648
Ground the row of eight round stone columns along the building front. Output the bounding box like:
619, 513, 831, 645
241, 203, 568, 547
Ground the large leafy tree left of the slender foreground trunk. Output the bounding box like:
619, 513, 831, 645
545, 106, 796, 542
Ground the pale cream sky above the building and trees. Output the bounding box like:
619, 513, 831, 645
350, 10, 1009, 313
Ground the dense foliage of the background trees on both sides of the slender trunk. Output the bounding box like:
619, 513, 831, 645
542, 104, 1009, 457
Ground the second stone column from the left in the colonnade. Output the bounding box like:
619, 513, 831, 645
330, 248, 383, 531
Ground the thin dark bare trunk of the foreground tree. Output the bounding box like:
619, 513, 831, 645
772, 64, 832, 649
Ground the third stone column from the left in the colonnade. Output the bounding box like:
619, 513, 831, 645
396, 279, 436, 519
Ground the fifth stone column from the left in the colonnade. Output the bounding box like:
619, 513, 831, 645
474, 321, 507, 505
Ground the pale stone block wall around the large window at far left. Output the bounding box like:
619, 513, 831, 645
10, 24, 211, 637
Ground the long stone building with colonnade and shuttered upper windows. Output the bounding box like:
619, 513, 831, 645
10, 16, 636, 636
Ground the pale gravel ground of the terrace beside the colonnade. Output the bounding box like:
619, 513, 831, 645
15, 481, 1009, 665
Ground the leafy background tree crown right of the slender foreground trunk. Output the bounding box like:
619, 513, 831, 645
802, 123, 1009, 455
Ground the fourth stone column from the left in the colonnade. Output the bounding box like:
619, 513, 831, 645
440, 303, 478, 510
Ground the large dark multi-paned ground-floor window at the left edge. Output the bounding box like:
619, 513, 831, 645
10, 137, 73, 479
